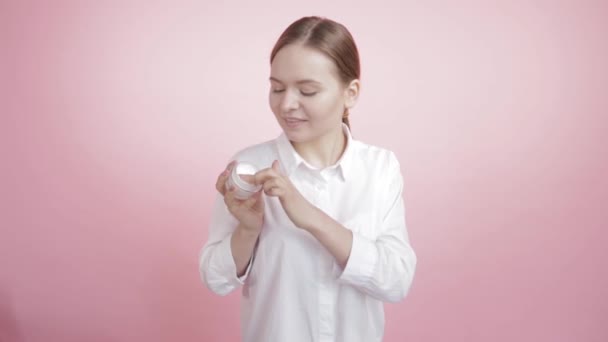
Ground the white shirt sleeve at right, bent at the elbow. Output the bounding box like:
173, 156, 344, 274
338, 153, 417, 302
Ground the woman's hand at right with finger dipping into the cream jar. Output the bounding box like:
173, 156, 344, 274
255, 160, 317, 229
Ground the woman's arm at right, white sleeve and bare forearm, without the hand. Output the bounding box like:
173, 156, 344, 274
305, 155, 417, 302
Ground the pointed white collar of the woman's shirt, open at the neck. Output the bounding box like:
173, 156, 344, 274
277, 123, 353, 181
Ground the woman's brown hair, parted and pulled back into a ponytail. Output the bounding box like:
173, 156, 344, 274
270, 16, 361, 128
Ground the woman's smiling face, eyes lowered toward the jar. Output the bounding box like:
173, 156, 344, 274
269, 44, 346, 142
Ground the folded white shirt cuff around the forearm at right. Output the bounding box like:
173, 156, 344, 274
334, 232, 378, 284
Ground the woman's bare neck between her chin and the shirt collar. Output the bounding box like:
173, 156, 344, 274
291, 126, 346, 168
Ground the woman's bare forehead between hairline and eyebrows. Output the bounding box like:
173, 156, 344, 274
270, 44, 338, 83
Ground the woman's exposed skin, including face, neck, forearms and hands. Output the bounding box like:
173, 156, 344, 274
216, 44, 360, 276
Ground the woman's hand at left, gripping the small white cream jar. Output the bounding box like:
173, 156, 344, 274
215, 161, 264, 234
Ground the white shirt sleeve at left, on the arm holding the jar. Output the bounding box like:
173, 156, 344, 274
199, 194, 255, 296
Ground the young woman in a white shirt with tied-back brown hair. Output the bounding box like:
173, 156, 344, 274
200, 17, 416, 342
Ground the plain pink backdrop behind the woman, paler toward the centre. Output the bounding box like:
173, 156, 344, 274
0, 0, 608, 342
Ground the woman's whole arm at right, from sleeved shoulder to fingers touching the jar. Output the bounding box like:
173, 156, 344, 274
255, 154, 417, 302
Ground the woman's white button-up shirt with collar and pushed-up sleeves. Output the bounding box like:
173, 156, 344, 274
199, 125, 416, 342
